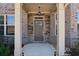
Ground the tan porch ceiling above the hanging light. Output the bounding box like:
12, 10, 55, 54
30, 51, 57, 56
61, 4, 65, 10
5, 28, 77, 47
23, 3, 56, 12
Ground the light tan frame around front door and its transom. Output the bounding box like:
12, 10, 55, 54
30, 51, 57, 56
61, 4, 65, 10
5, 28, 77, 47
33, 16, 45, 42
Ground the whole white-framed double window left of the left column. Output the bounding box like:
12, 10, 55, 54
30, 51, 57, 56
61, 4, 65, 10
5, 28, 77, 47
0, 15, 15, 35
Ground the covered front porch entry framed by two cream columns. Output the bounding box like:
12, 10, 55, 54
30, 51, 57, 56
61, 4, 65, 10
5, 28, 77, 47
14, 3, 66, 56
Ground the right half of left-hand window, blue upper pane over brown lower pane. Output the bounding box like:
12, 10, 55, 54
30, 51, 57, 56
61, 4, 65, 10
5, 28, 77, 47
6, 15, 14, 35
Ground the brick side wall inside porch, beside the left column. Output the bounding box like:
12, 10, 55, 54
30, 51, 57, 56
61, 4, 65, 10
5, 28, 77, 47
22, 10, 29, 44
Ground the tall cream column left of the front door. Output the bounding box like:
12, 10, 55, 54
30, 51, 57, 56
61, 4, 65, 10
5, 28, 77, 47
14, 3, 22, 56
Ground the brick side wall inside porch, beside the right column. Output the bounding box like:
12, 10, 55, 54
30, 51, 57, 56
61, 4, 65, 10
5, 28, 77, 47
49, 14, 57, 47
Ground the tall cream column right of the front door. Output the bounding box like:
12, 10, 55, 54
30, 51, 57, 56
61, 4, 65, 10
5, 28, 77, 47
57, 3, 65, 56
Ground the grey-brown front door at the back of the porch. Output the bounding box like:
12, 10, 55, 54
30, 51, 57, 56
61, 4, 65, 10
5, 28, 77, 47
34, 20, 44, 41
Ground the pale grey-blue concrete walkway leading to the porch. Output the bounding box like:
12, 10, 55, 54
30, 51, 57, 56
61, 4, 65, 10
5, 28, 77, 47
23, 43, 55, 56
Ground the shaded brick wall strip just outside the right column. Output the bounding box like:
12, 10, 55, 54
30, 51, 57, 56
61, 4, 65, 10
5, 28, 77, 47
65, 4, 71, 47
